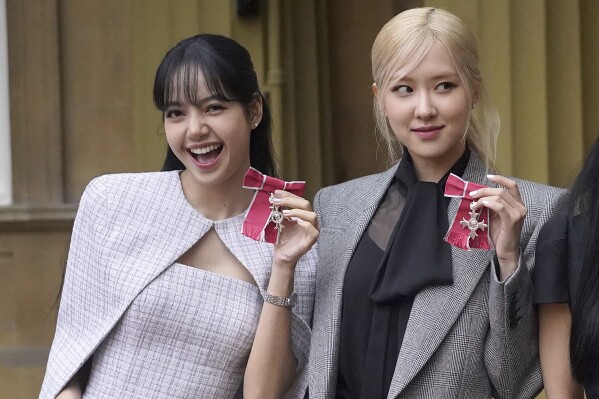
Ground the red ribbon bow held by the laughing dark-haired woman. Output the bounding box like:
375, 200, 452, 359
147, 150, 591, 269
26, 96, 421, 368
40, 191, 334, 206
241, 168, 306, 243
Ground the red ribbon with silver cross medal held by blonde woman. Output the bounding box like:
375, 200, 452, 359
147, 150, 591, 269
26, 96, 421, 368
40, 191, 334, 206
445, 173, 491, 251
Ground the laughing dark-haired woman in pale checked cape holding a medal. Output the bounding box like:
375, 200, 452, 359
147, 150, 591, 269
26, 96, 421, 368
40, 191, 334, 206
40, 35, 318, 399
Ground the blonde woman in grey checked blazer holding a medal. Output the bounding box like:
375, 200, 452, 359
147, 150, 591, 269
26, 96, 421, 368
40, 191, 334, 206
309, 8, 562, 399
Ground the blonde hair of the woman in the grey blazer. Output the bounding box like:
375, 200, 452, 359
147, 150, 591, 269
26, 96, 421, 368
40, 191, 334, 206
372, 7, 499, 170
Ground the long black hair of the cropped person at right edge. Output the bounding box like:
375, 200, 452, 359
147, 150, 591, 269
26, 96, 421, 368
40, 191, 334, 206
568, 139, 599, 383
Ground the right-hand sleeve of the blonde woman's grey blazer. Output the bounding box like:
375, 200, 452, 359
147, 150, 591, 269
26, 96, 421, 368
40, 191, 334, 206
484, 182, 565, 399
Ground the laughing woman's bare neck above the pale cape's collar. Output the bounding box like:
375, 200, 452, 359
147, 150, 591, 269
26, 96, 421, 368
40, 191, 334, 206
181, 171, 254, 220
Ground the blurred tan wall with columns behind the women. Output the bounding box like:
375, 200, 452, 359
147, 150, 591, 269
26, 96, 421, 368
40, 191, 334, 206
0, 0, 599, 399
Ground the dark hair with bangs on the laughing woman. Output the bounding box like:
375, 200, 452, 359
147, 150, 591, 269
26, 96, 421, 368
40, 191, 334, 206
154, 34, 277, 176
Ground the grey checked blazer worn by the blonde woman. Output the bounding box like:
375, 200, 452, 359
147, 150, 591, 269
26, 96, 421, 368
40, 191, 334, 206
309, 152, 565, 399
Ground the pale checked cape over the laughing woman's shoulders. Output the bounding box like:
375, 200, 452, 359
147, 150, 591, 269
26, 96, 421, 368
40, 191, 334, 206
40, 171, 316, 399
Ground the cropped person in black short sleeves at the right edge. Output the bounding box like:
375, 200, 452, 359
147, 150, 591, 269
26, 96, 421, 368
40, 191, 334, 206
534, 140, 599, 399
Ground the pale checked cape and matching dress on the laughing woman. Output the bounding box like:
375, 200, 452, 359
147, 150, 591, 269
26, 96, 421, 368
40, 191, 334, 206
40, 171, 316, 399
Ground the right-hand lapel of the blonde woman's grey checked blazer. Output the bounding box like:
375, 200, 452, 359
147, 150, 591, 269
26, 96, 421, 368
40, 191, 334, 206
388, 152, 495, 398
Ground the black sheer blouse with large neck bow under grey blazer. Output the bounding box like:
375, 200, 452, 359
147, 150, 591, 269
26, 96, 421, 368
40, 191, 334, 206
337, 149, 470, 399
